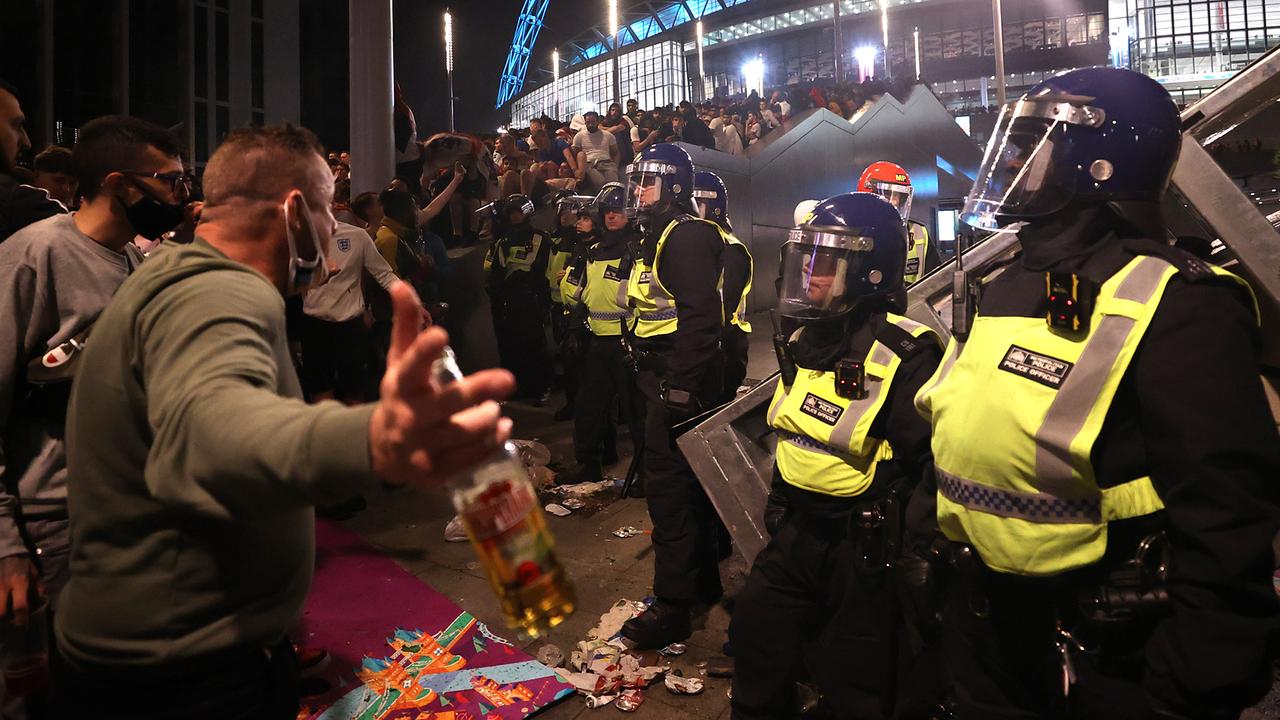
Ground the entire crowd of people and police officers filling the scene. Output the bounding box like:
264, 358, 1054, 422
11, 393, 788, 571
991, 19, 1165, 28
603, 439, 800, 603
0, 58, 1280, 720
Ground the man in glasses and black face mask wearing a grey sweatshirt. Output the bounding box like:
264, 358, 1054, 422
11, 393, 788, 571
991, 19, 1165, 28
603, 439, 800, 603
0, 115, 187, 655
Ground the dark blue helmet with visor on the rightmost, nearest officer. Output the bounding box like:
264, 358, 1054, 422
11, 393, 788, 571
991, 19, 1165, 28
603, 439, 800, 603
961, 68, 1181, 229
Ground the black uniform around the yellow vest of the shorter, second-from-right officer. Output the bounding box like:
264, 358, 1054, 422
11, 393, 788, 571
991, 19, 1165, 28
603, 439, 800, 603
730, 310, 941, 719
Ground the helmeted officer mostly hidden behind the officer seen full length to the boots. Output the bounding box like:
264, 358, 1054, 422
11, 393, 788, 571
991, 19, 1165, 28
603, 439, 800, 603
694, 170, 754, 402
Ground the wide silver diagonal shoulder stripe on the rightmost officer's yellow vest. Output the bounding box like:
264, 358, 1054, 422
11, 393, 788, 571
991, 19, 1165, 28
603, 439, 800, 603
1036, 258, 1169, 497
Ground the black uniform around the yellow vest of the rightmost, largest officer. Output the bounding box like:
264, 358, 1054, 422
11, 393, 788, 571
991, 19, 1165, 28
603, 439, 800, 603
913, 210, 1280, 720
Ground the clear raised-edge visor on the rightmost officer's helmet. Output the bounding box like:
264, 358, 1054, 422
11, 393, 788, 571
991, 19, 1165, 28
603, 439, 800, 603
960, 96, 1103, 231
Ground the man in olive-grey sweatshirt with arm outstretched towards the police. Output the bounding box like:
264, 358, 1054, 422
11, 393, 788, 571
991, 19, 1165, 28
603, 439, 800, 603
54, 126, 515, 720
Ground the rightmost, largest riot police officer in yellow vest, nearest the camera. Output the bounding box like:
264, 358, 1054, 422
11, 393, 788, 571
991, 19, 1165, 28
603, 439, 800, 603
916, 68, 1280, 719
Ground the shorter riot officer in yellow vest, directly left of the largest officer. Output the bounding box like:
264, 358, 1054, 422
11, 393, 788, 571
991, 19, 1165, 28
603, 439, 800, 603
730, 192, 942, 719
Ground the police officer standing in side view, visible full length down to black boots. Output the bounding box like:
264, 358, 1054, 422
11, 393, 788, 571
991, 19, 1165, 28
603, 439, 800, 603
622, 143, 724, 648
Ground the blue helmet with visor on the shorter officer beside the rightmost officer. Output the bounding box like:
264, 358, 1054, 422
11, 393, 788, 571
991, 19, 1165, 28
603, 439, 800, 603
778, 192, 906, 320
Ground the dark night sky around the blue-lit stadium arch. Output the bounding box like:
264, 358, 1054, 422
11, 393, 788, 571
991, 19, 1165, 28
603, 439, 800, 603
394, 0, 606, 138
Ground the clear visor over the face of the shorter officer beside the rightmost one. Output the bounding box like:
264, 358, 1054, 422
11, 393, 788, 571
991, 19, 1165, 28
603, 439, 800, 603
778, 228, 872, 320
